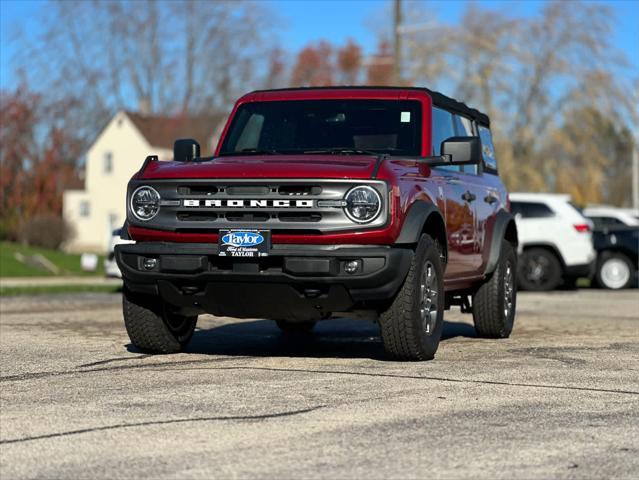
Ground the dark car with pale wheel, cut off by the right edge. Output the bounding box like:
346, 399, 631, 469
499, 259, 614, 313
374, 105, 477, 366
593, 226, 639, 290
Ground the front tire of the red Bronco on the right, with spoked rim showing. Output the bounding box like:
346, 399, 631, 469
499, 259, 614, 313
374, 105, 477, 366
379, 234, 444, 360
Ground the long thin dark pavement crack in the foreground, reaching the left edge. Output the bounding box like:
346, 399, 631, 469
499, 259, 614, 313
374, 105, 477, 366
0, 405, 326, 445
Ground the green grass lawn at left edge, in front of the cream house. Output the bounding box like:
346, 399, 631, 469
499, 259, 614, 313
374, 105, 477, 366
0, 242, 104, 277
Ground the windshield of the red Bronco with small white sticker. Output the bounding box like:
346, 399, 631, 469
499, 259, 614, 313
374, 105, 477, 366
220, 100, 422, 156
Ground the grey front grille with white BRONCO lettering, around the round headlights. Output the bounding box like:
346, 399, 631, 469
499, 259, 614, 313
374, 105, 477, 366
129, 179, 389, 234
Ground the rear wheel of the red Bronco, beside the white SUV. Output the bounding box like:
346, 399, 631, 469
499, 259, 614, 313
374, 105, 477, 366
473, 240, 517, 338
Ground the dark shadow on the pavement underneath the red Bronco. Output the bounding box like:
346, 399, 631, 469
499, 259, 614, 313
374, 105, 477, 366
127, 319, 476, 360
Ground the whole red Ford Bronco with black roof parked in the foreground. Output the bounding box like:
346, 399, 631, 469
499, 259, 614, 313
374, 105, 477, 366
116, 87, 517, 360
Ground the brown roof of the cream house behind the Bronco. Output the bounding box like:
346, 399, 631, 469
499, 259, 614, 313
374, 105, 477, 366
125, 111, 225, 156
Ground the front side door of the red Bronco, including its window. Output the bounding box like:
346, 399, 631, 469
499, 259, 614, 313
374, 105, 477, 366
432, 107, 476, 280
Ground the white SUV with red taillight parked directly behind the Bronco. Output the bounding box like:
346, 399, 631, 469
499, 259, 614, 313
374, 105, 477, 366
510, 193, 597, 291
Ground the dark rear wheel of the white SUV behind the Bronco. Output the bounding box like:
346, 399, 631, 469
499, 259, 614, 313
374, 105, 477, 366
517, 248, 562, 292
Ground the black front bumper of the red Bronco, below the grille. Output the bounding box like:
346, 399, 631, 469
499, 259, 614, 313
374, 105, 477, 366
115, 242, 413, 320
